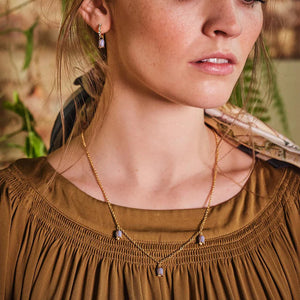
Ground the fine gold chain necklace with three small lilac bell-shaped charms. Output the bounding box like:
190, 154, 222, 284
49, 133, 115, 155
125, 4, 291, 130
81, 131, 219, 277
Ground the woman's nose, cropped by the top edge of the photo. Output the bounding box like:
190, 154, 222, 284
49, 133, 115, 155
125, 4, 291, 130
202, 0, 242, 37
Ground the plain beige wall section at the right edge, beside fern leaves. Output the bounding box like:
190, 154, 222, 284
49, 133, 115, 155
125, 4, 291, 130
270, 60, 300, 145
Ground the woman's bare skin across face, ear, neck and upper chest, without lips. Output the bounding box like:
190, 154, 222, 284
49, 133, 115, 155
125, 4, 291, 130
48, 0, 262, 209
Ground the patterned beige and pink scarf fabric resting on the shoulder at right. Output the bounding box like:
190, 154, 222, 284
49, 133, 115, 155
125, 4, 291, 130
205, 103, 300, 168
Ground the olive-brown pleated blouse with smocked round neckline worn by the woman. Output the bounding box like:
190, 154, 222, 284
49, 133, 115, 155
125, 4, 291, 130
0, 158, 300, 300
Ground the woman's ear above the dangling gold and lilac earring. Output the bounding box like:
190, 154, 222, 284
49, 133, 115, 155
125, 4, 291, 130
79, 0, 111, 33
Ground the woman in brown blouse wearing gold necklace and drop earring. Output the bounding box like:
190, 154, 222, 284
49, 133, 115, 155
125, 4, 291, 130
0, 0, 300, 299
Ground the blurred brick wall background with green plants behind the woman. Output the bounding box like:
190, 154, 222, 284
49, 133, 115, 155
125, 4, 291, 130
0, 0, 300, 168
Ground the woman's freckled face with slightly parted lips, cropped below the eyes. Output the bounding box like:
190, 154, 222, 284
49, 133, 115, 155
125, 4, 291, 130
106, 0, 263, 108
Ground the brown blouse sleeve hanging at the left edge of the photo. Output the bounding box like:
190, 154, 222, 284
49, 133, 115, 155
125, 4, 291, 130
0, 165, 31, 300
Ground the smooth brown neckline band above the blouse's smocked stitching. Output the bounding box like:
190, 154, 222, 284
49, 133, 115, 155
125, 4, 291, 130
9, 158, 286, 244
